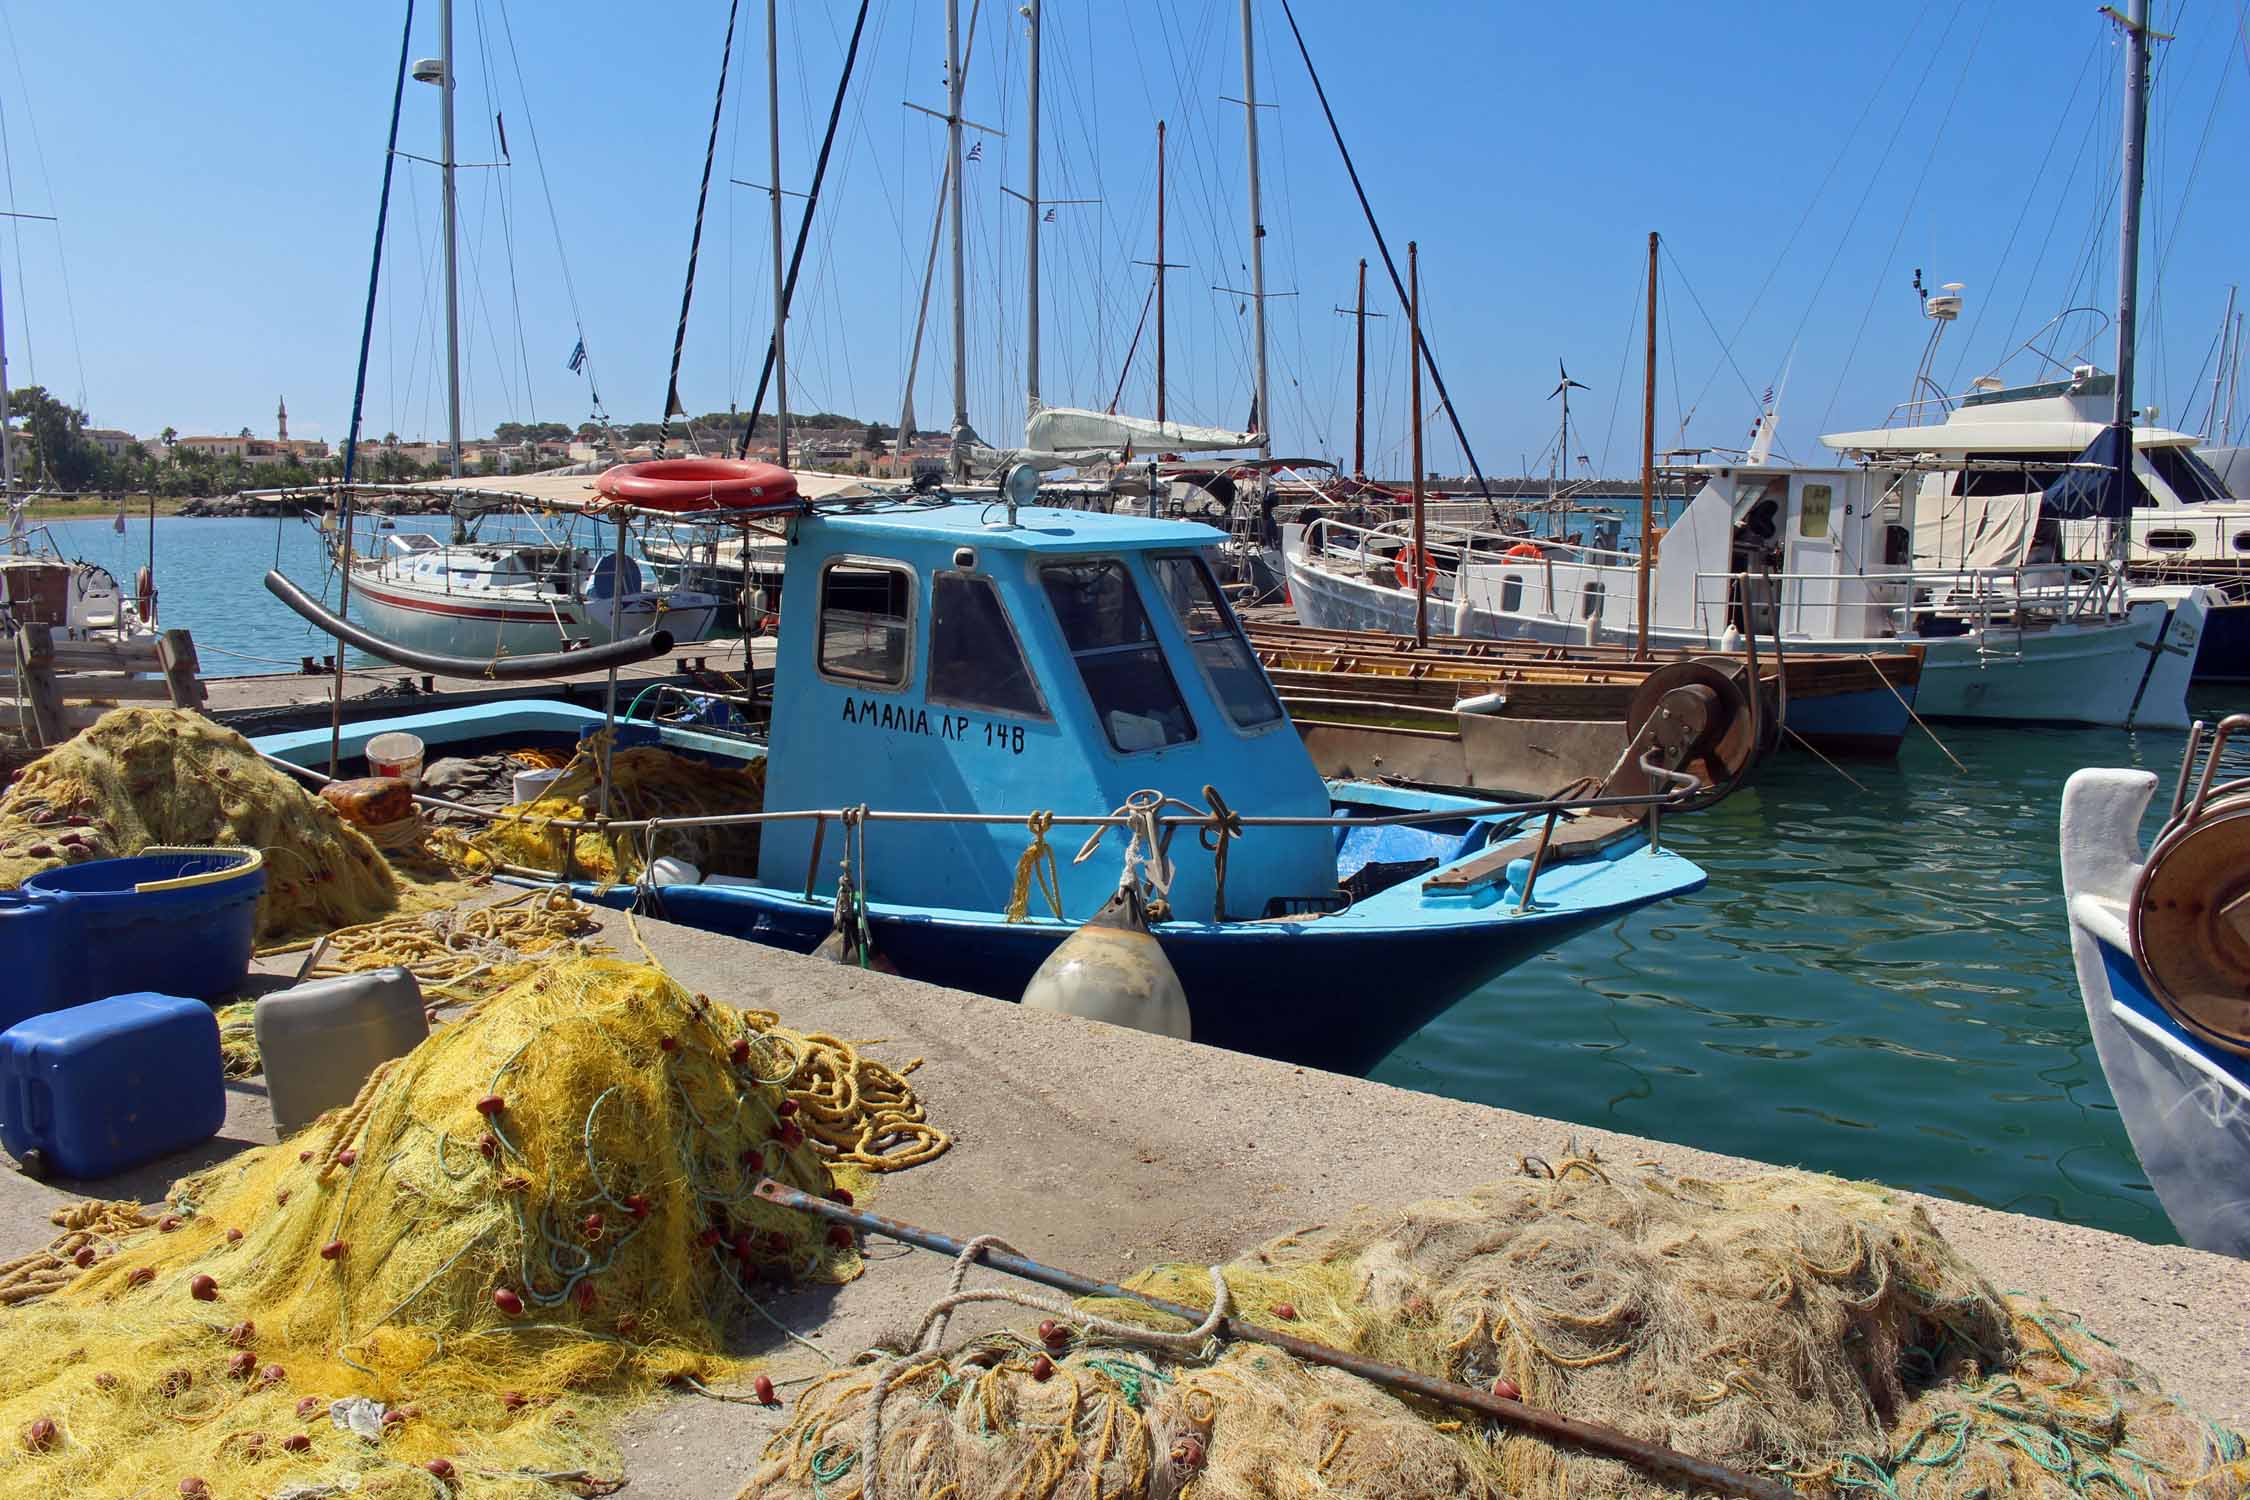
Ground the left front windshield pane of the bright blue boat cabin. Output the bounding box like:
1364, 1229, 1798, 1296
1040, 558, 1195, 753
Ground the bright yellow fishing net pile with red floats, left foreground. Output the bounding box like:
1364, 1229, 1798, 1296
0, 958, 895, 1498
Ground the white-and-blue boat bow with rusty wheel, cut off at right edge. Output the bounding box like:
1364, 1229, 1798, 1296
2061, 715, 2250, 1257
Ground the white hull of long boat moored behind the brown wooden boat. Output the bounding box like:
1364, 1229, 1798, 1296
1285, 546, 2203, 729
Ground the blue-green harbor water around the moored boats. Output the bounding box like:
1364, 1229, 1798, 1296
52, 517, 2246, 1241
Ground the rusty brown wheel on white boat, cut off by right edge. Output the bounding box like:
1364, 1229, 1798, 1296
2126, 798, 2250, 1057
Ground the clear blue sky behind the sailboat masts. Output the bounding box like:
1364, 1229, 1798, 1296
0, 0, 2250, 472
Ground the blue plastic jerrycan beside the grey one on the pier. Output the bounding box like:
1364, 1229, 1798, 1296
0, 992, 227, 1178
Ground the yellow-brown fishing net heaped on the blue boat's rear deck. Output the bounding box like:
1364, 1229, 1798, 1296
455, 731, 765, 882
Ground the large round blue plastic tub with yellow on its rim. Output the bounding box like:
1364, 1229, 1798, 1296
0, 848, 266, 1028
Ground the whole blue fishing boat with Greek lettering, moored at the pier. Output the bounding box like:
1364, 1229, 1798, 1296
259, 479, 1724, 1073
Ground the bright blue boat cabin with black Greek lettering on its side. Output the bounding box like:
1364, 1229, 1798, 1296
758, 499, 1337, 920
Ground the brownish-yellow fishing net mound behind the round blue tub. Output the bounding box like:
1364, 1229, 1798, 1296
0, 708, 398, 940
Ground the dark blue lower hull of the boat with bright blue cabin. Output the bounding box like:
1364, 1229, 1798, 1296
576, 870, 1665, 1075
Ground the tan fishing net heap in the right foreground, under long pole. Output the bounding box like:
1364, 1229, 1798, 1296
743, 1158, 2250, 1500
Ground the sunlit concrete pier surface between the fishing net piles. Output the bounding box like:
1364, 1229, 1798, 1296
0, 913, 2250, 1500
